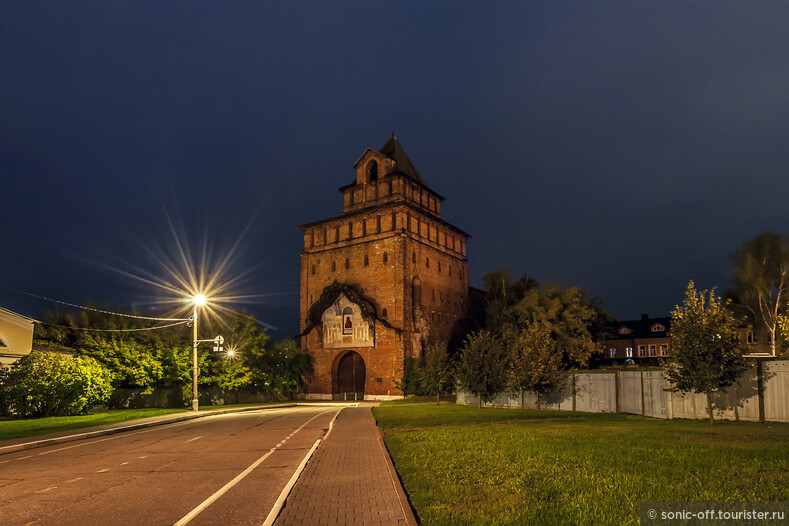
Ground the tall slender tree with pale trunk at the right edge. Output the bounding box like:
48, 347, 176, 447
734, 232, 789, 356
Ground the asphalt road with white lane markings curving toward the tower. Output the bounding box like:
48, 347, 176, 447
0, 406, 340, 526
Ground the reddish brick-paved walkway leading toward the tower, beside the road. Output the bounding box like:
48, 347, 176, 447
275, 406, 416, 526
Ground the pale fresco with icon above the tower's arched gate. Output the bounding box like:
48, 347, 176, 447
321, 294, 375, 349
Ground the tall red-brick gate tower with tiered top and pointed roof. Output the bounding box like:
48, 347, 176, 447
299, 135, 469, 400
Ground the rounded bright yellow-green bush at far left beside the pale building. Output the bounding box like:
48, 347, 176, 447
4, 352, 112, 417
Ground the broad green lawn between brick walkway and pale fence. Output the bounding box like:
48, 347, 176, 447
373, 405, 789, 525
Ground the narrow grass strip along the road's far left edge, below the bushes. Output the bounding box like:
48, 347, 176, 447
0, 402, 284, 440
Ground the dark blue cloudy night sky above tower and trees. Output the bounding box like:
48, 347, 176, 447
0, 1, 789, 338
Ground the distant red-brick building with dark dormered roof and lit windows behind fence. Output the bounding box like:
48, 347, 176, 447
603, 314, 671, 365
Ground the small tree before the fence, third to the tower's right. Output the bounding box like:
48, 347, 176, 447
505, 323, 567, 411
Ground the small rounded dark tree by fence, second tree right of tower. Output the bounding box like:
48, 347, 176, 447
457, 330, 507, 407
